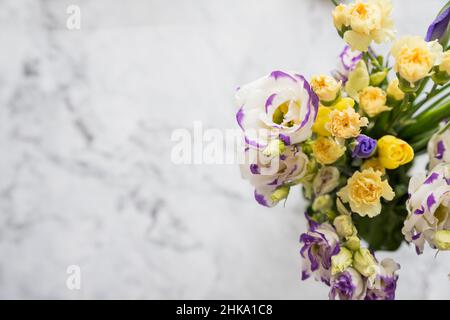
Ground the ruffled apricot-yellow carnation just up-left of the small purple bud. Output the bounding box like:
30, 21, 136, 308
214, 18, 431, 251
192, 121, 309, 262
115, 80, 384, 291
326, 107, 369, 139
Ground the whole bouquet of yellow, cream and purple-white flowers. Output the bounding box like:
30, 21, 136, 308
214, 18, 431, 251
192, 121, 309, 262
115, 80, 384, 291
236, 0, 450, 299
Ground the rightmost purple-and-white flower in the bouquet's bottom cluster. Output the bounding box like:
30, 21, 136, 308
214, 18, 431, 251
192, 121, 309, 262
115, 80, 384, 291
365, 259, 400, 300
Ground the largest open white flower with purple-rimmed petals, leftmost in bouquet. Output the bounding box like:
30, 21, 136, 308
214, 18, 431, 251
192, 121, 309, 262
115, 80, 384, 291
236, 71, 319, 149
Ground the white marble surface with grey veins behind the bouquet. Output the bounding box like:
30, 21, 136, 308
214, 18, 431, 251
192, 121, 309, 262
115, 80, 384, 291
0, 0, 450, 299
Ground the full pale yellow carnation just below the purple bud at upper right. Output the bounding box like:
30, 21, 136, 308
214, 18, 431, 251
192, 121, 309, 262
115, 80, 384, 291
391, 36, 442, 87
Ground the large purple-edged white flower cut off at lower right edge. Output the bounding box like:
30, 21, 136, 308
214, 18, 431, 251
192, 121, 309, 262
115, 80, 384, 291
402, 163, 450, 254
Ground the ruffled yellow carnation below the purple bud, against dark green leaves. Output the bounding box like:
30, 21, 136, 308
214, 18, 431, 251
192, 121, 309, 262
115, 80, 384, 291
337, 168, 395, 218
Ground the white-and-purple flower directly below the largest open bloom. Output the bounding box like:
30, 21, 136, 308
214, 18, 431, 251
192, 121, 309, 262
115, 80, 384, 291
241, 146, 308, 207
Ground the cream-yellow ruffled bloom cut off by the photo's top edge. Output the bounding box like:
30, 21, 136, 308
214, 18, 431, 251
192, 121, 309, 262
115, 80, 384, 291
333, 0, 394, 51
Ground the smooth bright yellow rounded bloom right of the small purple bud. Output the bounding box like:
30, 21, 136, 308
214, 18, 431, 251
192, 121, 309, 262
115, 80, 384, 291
377, 135, 414, 169
